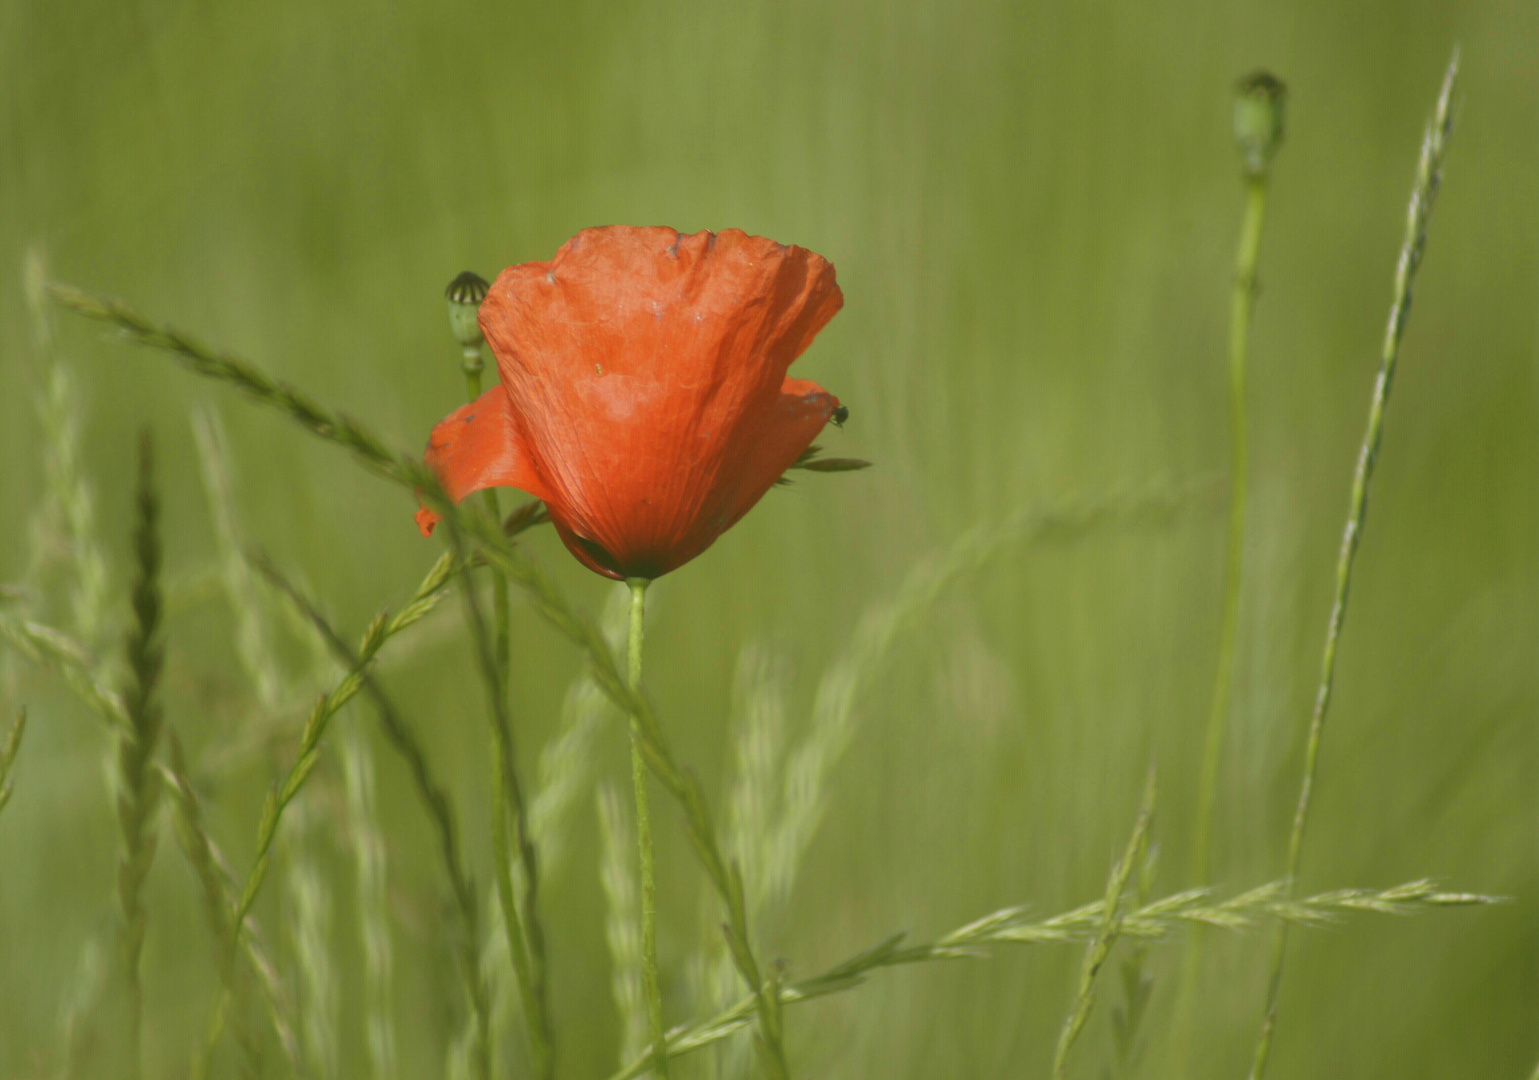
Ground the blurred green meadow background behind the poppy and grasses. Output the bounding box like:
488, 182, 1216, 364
0, 0, 1539, 1078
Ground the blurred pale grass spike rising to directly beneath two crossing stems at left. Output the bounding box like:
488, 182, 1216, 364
342, 723, 396, 1080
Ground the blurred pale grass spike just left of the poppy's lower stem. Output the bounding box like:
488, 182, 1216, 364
597, 783, 646, 1063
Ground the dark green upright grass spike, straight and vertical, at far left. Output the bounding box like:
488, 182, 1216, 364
117, 429, 165, 1077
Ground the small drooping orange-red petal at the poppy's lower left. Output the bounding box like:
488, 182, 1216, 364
416, 385, 545, 537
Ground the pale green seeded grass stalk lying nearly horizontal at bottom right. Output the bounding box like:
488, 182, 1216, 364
608, 880, 1497, 1080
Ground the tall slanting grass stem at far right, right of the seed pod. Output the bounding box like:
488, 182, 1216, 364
1250, 49, 1459, 1080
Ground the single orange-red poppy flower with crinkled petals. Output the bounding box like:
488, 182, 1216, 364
417, 226, 843, 578
